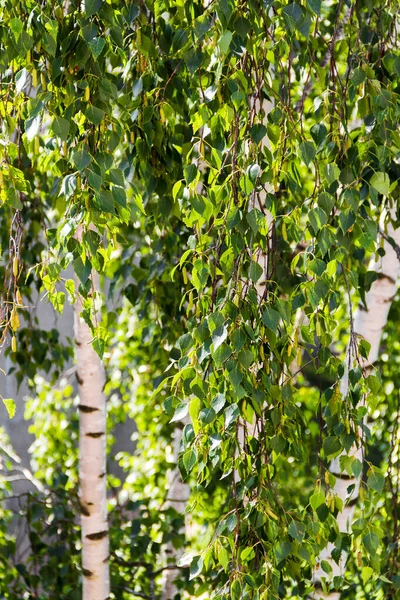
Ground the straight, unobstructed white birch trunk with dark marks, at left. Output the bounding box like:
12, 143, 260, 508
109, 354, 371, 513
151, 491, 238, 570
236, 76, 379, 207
75, 270, 110, 600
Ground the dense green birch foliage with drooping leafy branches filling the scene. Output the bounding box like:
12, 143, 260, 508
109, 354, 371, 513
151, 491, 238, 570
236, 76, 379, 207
0, 0, 400, 600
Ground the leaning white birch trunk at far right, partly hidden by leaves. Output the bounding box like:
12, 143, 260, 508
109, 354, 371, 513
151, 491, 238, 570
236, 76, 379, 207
315, 217, 400, 600
